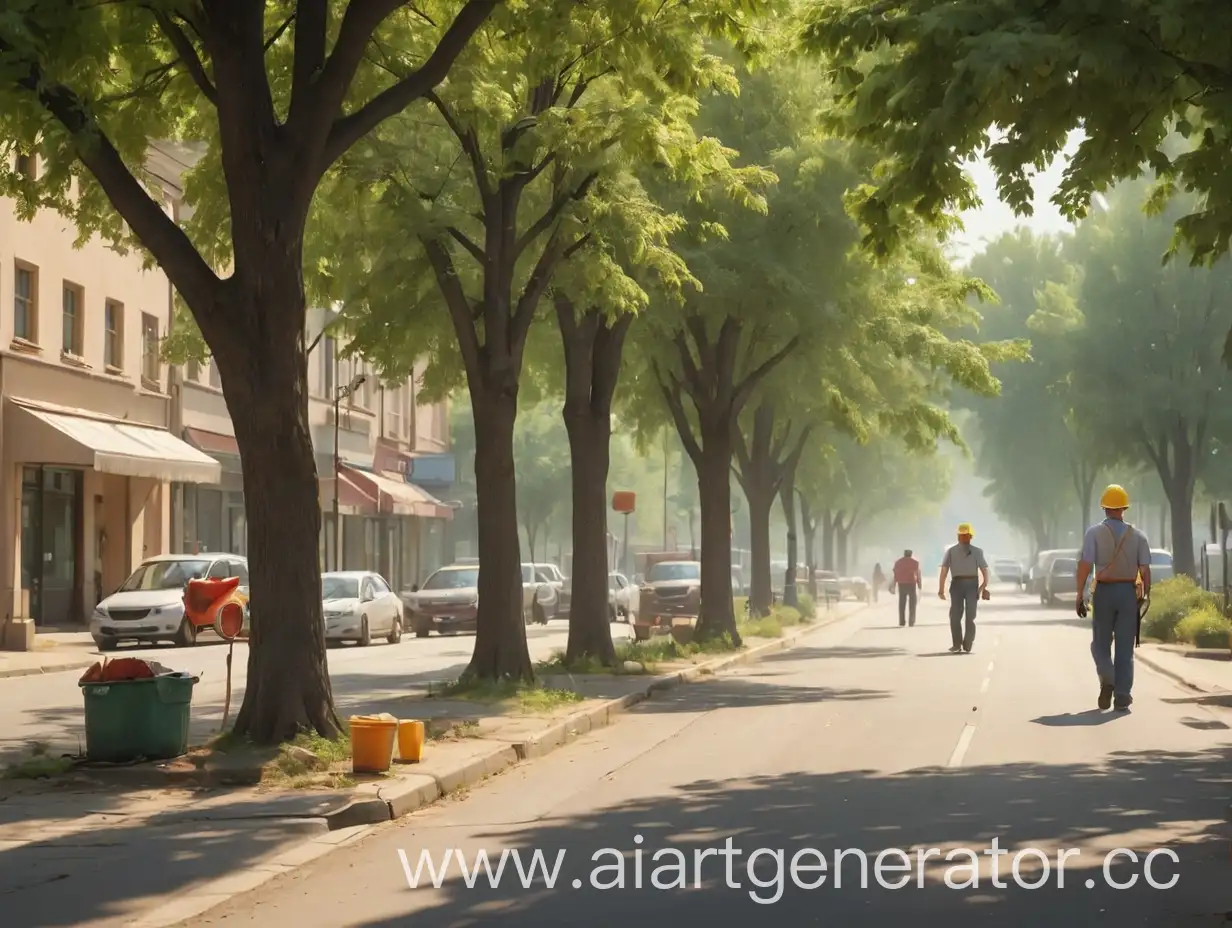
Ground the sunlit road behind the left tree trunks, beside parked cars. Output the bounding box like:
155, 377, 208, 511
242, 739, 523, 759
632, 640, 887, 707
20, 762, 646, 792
0, 620, 620, 764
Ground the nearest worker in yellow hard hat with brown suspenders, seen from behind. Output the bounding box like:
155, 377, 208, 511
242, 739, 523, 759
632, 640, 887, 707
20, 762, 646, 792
1076, 483, 1151, 711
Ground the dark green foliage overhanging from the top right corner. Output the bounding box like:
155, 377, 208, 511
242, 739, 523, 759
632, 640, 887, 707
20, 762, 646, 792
802, 0, 1232, 354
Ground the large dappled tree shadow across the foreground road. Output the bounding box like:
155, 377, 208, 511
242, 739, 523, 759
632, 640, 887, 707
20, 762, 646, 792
347, 746, 1232, 928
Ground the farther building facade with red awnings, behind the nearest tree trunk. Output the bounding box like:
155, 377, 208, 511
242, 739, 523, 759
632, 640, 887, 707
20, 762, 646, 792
172, 309, 455, 590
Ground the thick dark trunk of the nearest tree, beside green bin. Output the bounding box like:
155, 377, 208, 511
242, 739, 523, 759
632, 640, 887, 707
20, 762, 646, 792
225, 285, 340, 744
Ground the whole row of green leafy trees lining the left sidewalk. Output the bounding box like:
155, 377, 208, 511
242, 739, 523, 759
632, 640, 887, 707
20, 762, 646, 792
0, 0, 1039, 742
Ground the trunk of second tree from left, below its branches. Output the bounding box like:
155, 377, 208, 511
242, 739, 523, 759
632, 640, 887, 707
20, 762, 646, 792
463, 385, 535, 682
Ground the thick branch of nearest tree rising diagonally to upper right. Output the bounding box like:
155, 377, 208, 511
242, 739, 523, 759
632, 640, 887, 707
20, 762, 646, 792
320, 0, 501, 166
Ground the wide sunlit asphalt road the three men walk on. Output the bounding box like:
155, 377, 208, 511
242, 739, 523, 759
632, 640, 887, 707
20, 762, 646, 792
193, 585, 1232, 928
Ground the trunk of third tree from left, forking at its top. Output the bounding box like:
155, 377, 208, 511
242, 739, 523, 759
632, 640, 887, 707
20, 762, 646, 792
556, 295, 632, 667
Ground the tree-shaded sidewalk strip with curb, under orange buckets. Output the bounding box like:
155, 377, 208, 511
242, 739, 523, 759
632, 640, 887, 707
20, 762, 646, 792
0, 603, 864, 928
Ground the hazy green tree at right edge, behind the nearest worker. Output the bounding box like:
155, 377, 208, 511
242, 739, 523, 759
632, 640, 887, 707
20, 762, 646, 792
1072, 184, 1232, 576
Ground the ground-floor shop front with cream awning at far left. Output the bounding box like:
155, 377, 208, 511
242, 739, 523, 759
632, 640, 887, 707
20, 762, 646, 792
0, 397, 219, 626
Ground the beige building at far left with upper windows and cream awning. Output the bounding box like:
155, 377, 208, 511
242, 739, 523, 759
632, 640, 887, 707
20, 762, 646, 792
0, 152, 221, 626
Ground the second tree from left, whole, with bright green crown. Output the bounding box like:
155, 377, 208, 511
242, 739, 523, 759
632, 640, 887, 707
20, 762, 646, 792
322, 0, 773, 680
